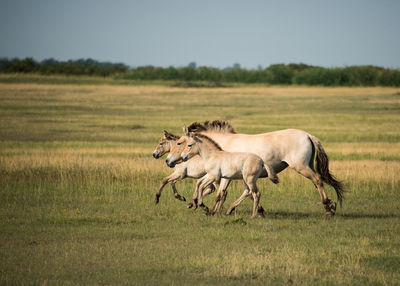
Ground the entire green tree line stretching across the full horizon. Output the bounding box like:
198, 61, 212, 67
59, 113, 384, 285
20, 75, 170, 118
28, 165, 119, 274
0, 58, 400, 86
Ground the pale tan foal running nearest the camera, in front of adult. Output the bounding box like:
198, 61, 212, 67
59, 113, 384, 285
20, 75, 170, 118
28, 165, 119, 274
173, 126, 278, 217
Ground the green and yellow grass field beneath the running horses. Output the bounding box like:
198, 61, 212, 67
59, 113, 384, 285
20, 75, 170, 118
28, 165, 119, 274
0, 76, 400, 285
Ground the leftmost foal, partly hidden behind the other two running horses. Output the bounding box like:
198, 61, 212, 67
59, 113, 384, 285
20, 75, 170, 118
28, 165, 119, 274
153, 130, 215, 204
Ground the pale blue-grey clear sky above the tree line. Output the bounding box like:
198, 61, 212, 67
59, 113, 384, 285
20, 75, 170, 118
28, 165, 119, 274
0, 0, 400, 68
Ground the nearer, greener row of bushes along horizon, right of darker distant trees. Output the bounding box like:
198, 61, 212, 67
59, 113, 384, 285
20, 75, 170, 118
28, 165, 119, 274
119, 64, 400, 86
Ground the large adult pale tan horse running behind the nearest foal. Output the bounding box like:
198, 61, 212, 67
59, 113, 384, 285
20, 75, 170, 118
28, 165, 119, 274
167, 120, 345, 216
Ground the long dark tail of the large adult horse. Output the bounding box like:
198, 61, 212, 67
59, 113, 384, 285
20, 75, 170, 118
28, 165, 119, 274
309, 135, 345, 205
